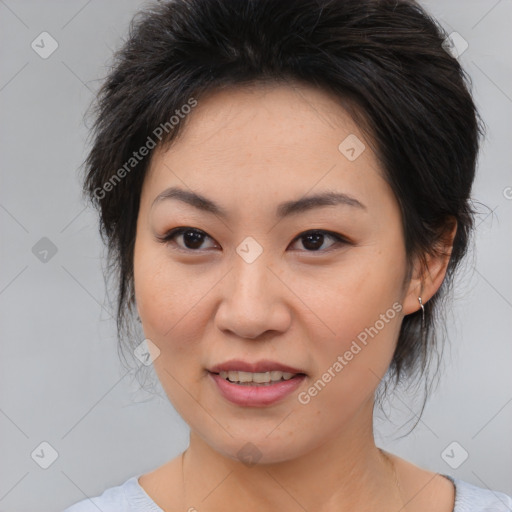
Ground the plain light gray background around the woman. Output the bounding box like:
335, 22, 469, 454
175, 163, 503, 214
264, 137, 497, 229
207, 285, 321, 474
0, 0, 512, 512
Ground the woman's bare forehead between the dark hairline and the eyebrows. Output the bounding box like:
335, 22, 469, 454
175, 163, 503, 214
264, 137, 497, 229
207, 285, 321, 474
140, 84, 386, 212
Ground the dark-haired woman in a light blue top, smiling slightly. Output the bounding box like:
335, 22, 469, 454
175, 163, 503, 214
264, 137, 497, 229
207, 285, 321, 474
63, 0, 512, 512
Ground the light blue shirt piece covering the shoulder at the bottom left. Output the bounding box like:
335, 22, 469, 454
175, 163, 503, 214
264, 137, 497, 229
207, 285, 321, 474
63, 475, 162, 512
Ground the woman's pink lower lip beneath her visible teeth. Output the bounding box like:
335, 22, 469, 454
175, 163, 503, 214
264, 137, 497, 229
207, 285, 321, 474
209, 372, 306, 407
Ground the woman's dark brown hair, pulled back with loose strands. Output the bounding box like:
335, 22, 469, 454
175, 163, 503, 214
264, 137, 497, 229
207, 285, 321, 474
84, 0, 483, 424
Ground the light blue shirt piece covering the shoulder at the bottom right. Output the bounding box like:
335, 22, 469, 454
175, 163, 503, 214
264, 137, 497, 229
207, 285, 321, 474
452, 475, 512, 512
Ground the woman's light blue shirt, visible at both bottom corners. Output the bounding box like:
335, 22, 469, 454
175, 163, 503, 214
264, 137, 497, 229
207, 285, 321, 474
63, 475, 512, 512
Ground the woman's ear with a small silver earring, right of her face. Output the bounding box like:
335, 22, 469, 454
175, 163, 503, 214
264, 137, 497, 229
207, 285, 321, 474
403, 218, 457, 315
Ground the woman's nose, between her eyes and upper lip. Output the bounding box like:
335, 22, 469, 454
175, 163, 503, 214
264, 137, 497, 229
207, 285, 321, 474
215, 257, 291, 339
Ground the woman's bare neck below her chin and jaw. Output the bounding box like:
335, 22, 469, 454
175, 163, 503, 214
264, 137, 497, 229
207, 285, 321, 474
183, 402, 401, 512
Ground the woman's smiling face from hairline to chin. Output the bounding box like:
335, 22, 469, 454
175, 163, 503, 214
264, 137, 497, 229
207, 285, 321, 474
134, 86, 418, 463
